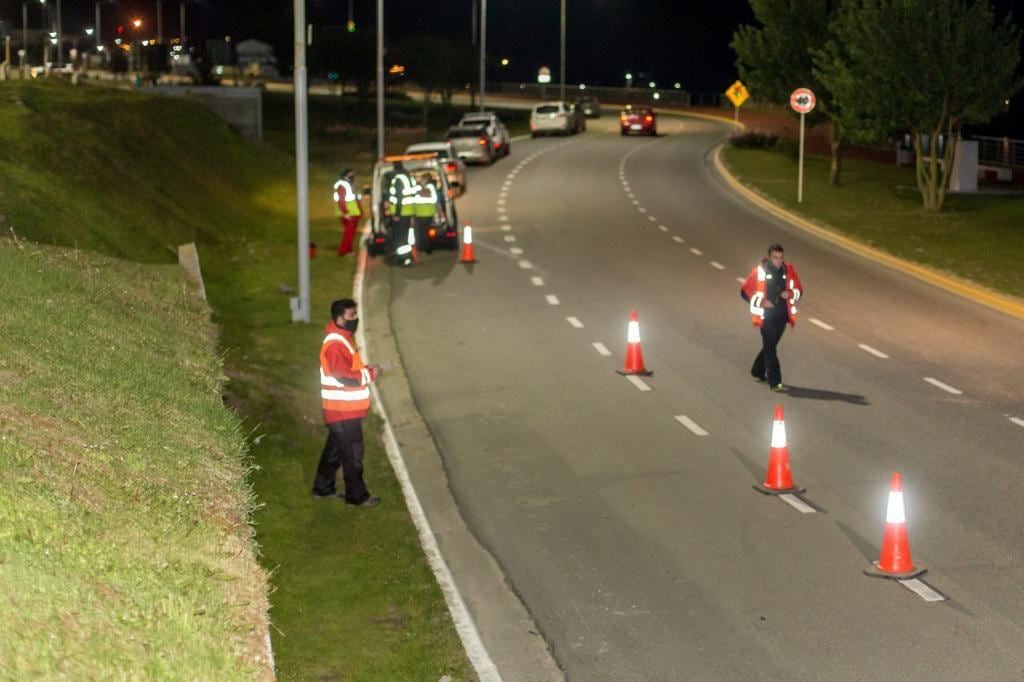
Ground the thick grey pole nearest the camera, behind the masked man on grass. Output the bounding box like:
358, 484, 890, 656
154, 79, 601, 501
292, 0, 309, 323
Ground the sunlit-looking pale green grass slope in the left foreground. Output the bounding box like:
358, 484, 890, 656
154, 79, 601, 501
0, 240, 266, 679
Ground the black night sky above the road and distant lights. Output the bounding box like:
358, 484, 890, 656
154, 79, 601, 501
0, 0, 1024, 92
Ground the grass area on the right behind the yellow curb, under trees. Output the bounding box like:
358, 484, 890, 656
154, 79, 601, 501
723, 147, 1024, 297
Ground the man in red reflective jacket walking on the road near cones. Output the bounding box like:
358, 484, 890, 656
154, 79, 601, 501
739, 244, 804, 392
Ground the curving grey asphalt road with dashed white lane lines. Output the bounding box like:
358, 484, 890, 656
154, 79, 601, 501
378, 117, 1024, 680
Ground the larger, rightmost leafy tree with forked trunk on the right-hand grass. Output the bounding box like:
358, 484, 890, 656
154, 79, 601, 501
815, 0, 1022, 211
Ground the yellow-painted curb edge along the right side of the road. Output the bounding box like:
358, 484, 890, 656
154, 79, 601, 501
701, 141, 1024, 319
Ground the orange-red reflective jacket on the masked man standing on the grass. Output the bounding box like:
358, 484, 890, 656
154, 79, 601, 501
321, 324, 373, 424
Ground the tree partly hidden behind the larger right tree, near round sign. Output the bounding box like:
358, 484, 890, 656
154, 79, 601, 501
731, 0, 844, 184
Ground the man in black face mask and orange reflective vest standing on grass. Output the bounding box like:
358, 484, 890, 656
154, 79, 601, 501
313, 298, 381, 507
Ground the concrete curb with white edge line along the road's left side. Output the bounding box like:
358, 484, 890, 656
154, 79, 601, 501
353, 241, 564, 681
